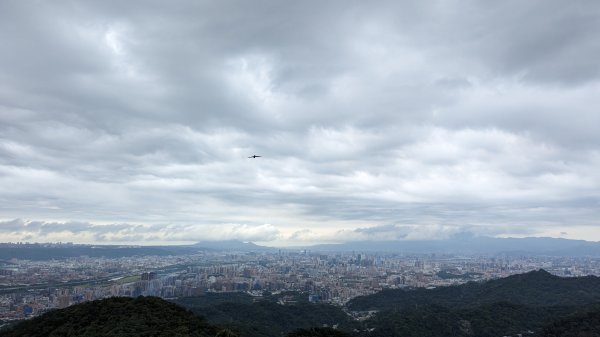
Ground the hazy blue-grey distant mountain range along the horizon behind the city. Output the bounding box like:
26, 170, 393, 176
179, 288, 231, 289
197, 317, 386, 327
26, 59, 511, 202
0, 235, 600, 260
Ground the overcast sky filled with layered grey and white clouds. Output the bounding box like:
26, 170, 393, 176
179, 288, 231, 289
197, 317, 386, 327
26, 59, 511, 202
0, 0, 600, 246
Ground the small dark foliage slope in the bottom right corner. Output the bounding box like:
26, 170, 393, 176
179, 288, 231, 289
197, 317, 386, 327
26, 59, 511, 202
541, 307, 600, 337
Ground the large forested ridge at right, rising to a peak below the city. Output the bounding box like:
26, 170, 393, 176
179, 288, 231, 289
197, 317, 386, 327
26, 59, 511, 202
350, 270, 600, 337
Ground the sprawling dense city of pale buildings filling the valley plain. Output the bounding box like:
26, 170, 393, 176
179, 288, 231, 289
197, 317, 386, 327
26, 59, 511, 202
0, 251, 600, 320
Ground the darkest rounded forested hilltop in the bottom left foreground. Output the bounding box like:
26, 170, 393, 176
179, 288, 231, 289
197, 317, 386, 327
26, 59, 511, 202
2, 297, 219, 337
